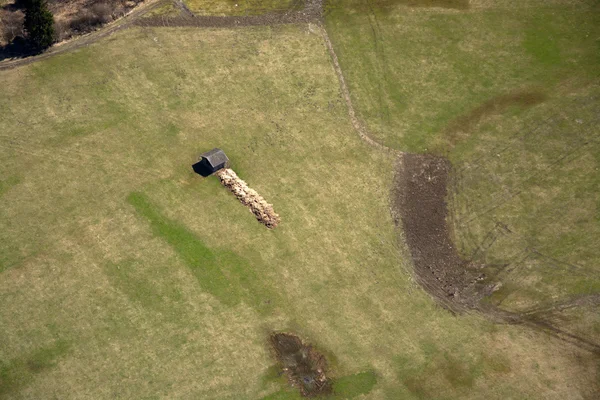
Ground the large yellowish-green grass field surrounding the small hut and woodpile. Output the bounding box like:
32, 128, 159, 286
0, 1, 598, 399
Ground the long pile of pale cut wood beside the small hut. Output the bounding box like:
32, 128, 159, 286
216, 168, 281, 229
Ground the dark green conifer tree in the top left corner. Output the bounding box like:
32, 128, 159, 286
24, 0, 54, 50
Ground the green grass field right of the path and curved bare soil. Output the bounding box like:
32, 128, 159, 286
327, 0, 600, 341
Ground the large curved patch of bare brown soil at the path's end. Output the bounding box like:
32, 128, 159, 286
392, 154, 489, 312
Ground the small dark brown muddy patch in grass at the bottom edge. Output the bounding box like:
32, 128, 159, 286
269, 332, 332, 397
